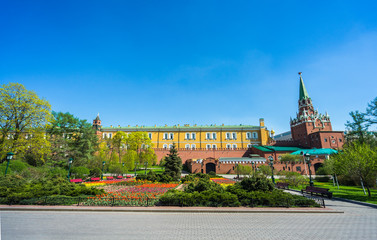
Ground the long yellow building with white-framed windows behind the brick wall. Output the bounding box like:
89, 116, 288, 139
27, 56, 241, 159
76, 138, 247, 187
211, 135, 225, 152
93, 117, 270, 149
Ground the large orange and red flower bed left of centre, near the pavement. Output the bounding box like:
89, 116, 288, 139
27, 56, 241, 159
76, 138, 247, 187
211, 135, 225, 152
83, 180, 178, 206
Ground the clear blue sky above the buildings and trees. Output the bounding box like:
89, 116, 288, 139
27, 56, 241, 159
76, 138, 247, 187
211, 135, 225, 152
0, 0, 377, 133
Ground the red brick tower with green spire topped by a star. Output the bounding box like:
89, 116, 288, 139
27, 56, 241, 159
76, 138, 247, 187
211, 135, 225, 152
290, 72, 332, 148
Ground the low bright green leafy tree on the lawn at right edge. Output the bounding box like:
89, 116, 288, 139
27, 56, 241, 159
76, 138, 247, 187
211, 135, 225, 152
327, 141, 377, 197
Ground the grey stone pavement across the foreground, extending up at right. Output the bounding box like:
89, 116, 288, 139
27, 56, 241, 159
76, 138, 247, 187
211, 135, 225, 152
0, 197, 377, 240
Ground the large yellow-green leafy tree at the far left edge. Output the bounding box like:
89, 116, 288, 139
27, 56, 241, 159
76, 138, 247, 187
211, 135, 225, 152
0, 83, 51, 159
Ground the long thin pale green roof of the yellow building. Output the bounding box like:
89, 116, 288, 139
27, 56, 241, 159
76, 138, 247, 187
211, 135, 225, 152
102, 124, 259, 130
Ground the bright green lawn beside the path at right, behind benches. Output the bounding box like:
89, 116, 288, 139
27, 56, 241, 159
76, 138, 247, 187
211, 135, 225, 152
292, 181, 377, 204
